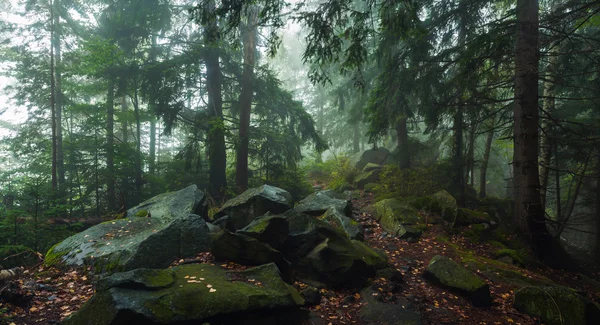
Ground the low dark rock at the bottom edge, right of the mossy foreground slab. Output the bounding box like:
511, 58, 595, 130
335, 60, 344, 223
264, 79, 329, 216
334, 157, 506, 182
359, 287, 422, 325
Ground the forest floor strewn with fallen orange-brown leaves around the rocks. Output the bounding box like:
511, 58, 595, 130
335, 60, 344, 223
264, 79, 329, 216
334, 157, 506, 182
0, 194, 600, 325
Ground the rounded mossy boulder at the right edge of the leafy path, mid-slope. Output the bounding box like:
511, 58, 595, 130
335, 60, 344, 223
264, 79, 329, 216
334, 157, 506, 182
373, 199, 425, 238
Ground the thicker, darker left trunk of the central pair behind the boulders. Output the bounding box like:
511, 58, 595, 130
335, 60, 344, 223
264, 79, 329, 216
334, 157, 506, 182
204, 0, 227, 199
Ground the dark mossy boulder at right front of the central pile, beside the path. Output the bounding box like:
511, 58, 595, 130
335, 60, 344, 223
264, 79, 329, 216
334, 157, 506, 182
282, 211, 387, 287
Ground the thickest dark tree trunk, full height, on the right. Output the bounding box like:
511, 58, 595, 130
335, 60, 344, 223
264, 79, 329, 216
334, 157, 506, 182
513, 0, 554, 259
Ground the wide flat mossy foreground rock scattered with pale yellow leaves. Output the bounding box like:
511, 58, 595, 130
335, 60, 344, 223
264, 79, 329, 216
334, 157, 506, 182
63, 264, 308, 325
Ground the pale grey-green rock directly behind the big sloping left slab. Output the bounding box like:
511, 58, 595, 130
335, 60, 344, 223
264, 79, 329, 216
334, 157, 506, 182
127, 185, 208, 221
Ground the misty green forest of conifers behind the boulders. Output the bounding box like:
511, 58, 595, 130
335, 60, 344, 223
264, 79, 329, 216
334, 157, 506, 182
0, 0, 600, 292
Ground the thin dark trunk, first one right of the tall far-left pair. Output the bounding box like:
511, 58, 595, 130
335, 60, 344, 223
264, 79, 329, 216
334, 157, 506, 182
106, 76, 116, 212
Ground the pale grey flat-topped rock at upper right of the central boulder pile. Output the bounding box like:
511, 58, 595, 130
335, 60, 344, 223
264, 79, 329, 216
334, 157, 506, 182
294, 191, 352, 217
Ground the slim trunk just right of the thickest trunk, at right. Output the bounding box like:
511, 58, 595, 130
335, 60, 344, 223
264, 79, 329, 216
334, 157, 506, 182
540, 44, 559, 211
